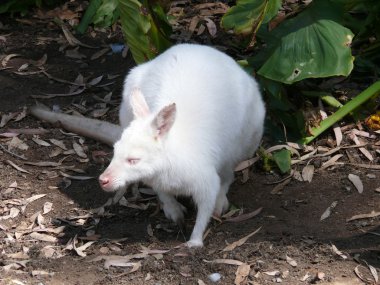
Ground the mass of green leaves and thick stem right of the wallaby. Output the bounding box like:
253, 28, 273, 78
222, 0, 380, 143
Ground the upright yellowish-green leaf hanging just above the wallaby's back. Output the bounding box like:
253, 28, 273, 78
119, 0, 171, 63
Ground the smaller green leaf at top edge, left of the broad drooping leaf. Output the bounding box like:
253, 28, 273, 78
221, 0, 281, 35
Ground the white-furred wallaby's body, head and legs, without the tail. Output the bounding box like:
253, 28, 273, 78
99, 44, 265, 246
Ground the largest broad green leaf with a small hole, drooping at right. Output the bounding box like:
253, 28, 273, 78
258, 0, 354, 84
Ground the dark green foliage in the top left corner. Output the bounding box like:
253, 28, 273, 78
0, 0, 58, 15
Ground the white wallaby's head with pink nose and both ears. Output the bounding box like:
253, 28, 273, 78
99, 88, 176, 191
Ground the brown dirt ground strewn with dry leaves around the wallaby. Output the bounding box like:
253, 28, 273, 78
0, 8, 380, 285
